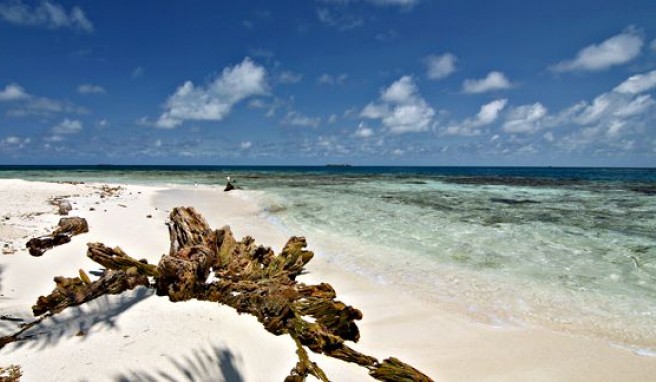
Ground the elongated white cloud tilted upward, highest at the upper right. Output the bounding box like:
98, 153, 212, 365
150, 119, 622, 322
551, 28, 644, 72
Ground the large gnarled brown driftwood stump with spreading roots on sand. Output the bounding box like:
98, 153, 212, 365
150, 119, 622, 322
14, 207, 431, 382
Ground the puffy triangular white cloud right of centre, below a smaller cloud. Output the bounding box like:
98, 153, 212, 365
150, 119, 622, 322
360, 76, 435, 134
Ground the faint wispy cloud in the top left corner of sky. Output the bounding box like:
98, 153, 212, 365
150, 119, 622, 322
0, 0, 93, 32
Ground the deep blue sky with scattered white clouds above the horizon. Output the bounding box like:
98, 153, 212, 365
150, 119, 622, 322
0, 0, 656, 167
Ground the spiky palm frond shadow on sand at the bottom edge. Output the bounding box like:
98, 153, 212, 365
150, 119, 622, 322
114, 346, 244, 382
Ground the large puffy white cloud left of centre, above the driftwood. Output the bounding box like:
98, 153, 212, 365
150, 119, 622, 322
156, 58, 268, 128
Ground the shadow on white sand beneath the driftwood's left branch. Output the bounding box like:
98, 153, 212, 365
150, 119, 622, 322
5, 287, 155, 350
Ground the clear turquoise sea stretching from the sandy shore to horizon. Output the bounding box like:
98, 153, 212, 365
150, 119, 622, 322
0, 166, 656, 355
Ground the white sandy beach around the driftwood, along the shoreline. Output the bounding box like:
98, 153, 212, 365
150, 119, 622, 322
0, 180, 656, 381
